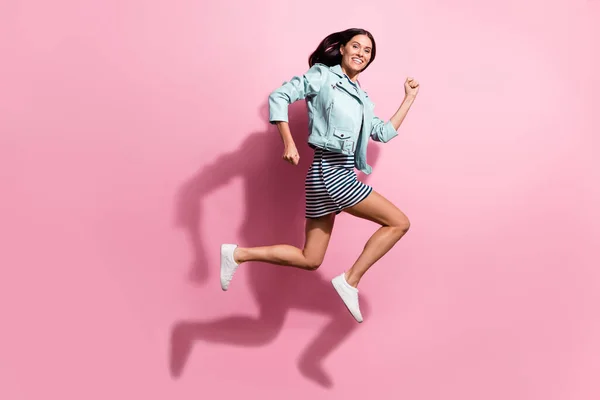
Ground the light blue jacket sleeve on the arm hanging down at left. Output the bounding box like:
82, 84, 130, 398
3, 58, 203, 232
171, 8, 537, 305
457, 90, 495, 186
269, 64, 327, 124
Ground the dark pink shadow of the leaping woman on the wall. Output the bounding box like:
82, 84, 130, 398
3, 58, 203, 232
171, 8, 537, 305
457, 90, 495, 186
170, 102, 379, 387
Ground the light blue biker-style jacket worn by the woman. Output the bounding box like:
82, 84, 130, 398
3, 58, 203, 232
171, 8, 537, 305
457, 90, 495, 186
269, 64, 398, 174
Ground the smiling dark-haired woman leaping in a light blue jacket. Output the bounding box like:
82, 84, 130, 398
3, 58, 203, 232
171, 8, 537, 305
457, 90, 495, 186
221, 29, 419, 322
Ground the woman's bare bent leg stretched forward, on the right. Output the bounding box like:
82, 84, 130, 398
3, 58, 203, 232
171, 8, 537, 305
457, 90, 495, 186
344, 190, 410, 287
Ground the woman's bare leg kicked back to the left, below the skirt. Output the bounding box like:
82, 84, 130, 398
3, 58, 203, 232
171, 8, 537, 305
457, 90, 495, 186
233, 214, 335, 270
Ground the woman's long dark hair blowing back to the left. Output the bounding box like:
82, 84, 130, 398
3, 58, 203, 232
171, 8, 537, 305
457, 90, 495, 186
308, 28, 376, 72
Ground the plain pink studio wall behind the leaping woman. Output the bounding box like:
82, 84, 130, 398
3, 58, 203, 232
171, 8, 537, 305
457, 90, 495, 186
0, 0, 600, 400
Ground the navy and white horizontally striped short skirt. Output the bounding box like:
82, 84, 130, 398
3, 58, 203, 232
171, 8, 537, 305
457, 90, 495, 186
304, 148, 373, 218
